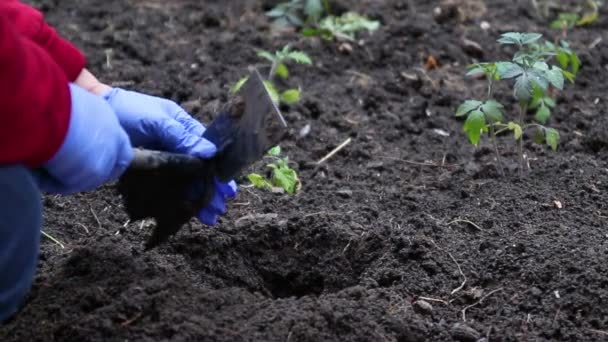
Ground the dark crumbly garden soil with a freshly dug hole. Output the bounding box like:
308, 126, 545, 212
0, 0, 608, 342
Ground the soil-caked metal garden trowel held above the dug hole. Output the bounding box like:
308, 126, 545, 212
118, 68, 287, 249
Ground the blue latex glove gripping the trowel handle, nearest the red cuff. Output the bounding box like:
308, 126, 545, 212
35, 84, 133, 194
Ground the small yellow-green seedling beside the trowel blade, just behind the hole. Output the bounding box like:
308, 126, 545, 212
247, 146, 301, 194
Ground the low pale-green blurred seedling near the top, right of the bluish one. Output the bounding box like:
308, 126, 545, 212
302, 12, 380, 41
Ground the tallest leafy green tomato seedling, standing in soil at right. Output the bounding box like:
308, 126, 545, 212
456, 32, 581, 174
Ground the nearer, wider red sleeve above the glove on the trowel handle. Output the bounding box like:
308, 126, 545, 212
0, 13, 71, 167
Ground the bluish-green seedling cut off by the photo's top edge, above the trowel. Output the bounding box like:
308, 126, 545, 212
266, 0, 330, 28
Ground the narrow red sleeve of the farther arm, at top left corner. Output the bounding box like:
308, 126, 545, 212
0, 0, 86, 81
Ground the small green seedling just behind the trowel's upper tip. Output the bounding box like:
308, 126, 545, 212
230, 45, 312, 105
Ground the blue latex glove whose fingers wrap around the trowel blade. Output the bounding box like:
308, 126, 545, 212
103, 88, 237, 225
